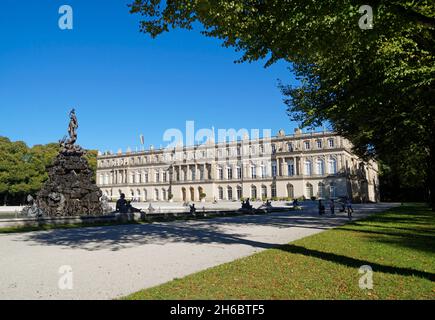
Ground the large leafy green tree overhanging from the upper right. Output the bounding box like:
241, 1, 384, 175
130, 0, 435, 209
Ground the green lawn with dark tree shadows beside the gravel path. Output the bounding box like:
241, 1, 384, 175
126, 204, 435, 300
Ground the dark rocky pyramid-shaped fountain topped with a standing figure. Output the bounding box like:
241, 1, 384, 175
23, 109, 105, 217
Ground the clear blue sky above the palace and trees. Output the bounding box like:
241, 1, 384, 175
0, 0, 295, 151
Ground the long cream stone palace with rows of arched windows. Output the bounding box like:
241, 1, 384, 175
97, 129, 379, 202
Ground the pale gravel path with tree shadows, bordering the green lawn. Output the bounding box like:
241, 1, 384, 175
0, 204, 392, 300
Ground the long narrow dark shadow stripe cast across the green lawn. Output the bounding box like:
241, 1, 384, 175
279, 244, 435, 281
